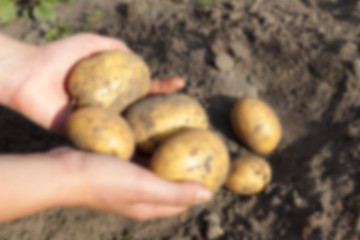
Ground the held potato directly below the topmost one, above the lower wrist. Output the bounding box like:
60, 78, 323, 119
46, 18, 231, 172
66, 107, 135, 160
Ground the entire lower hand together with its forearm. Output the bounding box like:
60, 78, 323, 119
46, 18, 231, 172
0, 148, 211, 222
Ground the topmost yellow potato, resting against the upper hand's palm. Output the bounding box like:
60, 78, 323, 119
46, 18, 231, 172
68, 51, 150, 112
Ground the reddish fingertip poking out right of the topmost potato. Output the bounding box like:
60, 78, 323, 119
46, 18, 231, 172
149, 77, 185, 95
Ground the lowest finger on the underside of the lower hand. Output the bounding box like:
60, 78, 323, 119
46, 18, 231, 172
129, 203, 188, 221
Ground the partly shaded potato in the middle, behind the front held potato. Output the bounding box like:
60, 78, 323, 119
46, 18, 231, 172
125, 94, 209, 153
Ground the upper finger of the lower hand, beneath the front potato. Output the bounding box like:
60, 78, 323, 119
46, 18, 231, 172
134, 169, 212, 206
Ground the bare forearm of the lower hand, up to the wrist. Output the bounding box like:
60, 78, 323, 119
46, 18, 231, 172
0, 154, 79, 222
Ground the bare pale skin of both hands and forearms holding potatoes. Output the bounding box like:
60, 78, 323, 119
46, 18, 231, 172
0, 34, 212, 223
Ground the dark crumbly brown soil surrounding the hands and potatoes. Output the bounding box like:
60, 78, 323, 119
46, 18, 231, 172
0, 0, 360, 240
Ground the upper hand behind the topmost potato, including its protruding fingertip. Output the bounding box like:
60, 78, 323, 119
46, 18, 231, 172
0, 34, 184, 133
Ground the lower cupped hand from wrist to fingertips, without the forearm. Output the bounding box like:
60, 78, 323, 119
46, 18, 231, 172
50, 148, 211, 220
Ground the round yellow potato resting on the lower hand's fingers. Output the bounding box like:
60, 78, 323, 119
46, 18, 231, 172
150, 129, 230, 193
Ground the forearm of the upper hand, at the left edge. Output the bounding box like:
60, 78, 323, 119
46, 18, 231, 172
0, 33, 37, 107
